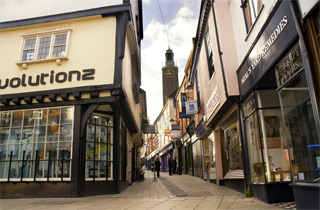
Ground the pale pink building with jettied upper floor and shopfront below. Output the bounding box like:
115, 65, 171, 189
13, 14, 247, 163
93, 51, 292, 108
187, 1, 245, 192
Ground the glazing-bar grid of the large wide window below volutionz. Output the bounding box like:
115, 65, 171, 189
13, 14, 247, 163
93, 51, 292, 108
0, 106, 74, 182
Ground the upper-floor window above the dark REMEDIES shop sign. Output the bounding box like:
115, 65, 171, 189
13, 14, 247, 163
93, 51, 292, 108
241, 0, 262, 32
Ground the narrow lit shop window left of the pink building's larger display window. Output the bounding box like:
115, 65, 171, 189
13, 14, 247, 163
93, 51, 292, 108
203, 133, 216, 179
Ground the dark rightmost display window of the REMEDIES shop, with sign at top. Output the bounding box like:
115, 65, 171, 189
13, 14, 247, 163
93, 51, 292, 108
275, 43, 320, 182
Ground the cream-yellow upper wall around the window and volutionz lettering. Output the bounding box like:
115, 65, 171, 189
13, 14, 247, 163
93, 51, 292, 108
0, 16, 116, 95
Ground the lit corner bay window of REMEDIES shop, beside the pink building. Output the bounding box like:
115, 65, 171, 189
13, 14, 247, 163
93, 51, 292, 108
244, 90, 291, 183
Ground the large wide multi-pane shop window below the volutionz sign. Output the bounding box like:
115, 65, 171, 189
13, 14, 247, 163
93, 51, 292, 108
0, 107, 73, 181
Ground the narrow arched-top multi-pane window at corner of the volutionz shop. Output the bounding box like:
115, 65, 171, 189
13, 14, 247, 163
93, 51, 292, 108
86, 113, 113, 180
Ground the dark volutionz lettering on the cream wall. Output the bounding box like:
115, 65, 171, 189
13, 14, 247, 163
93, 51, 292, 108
0, 69, 95, 89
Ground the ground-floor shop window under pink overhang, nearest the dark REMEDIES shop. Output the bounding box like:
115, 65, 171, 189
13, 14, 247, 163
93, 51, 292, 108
224, 120, 243, 178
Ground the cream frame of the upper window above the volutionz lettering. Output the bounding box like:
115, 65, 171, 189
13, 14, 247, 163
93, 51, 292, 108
16, 29, 71, 69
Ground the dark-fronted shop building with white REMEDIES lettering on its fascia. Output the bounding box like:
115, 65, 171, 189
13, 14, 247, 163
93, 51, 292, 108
230, 1, 320, 206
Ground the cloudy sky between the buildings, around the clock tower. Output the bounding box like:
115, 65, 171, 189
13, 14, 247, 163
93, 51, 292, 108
141, 0, 201, 123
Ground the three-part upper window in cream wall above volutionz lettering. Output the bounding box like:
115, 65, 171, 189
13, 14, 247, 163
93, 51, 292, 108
20, 31, 69, 62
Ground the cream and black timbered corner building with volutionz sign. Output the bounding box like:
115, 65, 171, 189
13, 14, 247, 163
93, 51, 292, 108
0, 0, 146, 198
